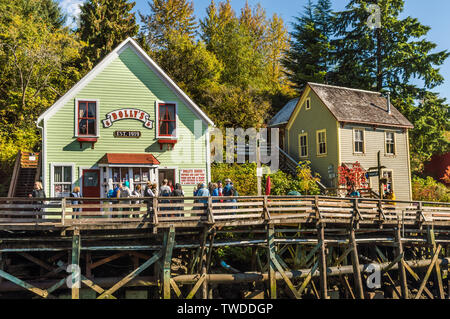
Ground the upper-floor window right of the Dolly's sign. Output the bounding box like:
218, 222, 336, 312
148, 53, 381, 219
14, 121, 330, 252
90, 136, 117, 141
156, 101, 178, 139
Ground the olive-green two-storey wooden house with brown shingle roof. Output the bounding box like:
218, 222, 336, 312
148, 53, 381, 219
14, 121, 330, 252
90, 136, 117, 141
269, 83, 413, 200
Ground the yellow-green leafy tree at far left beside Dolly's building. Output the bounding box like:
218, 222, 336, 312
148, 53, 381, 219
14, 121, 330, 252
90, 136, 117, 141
0, 0, 82, 195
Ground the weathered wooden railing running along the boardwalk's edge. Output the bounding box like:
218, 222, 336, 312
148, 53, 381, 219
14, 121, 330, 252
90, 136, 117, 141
0, 196, 450, 229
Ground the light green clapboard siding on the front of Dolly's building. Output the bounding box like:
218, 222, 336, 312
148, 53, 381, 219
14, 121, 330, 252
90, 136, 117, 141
45, 47, 208, 195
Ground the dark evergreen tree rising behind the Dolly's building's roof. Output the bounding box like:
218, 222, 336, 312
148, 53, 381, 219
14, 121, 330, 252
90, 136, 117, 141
78, 0, 139, 69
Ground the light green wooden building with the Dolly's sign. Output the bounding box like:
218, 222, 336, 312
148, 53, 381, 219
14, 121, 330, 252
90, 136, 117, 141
37, 38, 214, 197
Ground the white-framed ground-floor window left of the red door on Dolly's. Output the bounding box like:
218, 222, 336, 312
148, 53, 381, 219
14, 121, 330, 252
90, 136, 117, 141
50, 163, 75, 197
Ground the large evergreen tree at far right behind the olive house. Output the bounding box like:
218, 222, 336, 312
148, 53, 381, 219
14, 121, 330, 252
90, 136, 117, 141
332, 0, 449, 97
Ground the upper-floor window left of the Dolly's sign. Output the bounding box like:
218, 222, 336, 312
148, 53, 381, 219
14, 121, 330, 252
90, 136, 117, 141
75, 99, 100, 137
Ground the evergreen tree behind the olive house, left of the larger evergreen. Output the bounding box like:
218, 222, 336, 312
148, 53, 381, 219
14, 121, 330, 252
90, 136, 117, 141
283, 0, 333, 90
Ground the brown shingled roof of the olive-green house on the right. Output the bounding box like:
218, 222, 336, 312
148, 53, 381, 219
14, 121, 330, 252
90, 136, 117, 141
308, 83, 414, 128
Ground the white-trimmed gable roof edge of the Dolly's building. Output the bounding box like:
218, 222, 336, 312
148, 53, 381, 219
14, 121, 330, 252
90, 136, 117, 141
36, 38, 214, 125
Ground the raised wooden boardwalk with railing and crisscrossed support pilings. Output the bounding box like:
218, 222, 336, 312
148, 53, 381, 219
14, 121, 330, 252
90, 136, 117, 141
0, 196, 450, 299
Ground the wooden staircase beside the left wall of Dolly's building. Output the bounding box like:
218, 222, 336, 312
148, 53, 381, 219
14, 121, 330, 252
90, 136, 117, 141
8, 151, 41, 197
